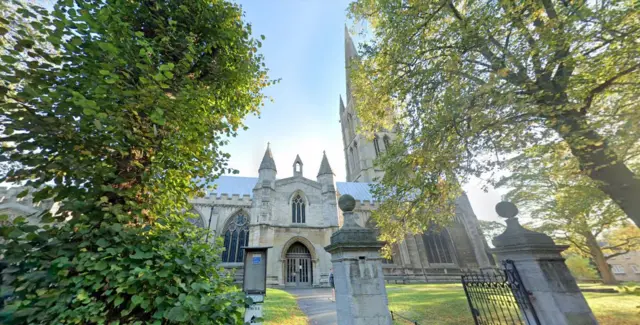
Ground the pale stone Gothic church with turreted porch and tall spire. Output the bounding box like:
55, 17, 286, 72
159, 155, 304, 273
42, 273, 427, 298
0, 31, 493, 287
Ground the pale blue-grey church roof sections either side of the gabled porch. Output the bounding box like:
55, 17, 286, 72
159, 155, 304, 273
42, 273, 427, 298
205, 176, 373, 201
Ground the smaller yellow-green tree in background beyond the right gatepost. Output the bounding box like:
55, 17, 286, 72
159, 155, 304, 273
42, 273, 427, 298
497, 143, 640, 284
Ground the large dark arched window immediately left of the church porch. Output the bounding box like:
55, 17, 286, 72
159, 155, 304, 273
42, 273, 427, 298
222, 212, 249, 263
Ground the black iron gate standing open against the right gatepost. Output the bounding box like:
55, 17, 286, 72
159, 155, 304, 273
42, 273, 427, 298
462, 260, 540, 325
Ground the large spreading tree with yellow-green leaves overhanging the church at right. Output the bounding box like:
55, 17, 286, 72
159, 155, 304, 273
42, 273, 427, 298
349, 0, 640, 234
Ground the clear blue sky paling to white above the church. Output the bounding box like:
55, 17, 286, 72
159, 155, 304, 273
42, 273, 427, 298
37, 0, 500, 220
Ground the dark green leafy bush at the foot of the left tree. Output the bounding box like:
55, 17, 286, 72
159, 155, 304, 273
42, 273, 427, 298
2, 214, 244, 324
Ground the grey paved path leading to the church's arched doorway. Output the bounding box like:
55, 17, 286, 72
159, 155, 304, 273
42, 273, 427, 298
286, 288, 338, 325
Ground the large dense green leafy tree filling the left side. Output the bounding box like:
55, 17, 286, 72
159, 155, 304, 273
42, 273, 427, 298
0, 0, 271, 324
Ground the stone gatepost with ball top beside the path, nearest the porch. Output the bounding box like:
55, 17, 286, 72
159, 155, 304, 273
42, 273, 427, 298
325, 195, 391, 325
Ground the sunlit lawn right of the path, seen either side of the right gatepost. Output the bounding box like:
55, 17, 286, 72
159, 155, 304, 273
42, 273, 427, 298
387, 284, 640, 325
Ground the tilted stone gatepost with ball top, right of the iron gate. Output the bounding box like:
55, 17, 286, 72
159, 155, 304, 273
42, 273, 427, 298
493, 202, 598, 325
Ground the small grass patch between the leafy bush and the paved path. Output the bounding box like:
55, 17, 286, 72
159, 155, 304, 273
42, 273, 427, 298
263, 289, 307, 325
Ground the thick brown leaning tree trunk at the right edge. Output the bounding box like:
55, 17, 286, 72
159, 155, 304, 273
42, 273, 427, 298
547, 110, 640, 227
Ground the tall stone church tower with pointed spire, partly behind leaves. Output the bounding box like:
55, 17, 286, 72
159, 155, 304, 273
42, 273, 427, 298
339, 26, 394, 183
